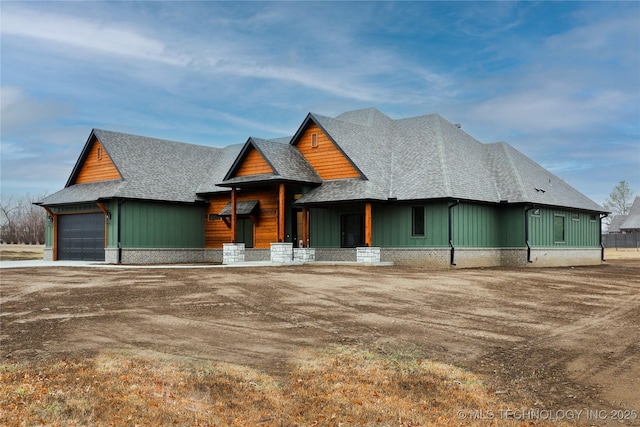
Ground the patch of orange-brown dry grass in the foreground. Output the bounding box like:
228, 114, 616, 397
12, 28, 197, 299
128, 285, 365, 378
0, 347, 562, 426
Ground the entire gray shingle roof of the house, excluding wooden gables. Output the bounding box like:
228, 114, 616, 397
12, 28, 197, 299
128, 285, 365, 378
41, 108, 608, 214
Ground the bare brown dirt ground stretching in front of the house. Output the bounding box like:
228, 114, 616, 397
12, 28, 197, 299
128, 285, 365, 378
0, 260, 640, 425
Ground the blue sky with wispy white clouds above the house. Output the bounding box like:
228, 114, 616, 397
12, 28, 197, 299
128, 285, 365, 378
0, 1, 640, 203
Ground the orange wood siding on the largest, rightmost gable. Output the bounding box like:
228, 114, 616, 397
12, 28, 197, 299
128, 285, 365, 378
296, 124, 360, 180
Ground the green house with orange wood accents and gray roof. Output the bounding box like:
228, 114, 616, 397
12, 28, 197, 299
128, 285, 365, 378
39, 108, 605, 267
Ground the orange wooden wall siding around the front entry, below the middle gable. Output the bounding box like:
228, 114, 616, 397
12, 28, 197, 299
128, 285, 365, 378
205, 186, 278, 249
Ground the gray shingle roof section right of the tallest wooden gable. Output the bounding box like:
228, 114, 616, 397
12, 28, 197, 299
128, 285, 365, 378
292, 108, 604, 212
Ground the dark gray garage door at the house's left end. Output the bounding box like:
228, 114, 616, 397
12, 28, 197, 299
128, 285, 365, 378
58, 212, 104, 261
